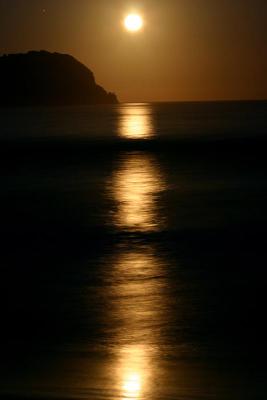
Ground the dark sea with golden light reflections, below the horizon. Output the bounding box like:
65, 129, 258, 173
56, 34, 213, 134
0, 103, 267, 400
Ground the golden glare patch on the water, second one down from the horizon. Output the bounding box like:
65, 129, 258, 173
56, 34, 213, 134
110, 153, 165, 232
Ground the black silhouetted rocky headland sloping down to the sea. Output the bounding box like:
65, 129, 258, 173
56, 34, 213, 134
0, 51, 118, 107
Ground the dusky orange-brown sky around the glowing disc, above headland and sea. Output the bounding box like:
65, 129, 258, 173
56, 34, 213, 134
0, 0, 267, 101
